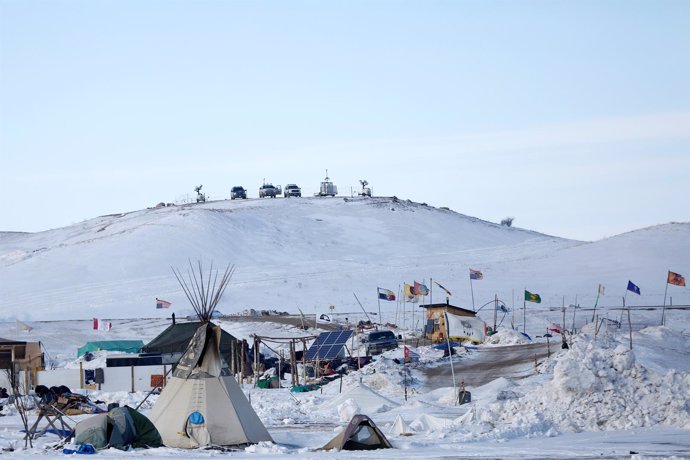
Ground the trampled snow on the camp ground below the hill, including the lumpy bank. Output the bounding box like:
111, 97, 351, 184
0, 306, 690, 459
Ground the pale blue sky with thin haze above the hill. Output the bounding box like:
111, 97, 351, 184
0, 0, 690, 240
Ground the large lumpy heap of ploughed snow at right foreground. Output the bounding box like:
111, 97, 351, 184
479, 328, 690, 437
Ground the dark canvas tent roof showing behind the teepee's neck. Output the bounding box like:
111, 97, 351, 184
141, 321, 237, 363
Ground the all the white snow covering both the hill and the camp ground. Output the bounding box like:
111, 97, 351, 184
0, 198, 690, 459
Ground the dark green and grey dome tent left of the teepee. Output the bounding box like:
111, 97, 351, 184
74, 406, 163, 450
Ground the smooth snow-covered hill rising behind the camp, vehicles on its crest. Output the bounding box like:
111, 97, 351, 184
0, 198, 690, 320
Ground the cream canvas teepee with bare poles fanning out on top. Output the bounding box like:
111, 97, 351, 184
149, 262, 273, 448
